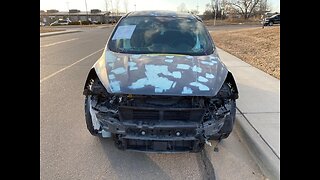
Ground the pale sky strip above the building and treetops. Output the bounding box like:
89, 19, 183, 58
40, 0, 280, 14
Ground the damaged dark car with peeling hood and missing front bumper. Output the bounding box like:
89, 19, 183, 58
83, 11, 238, 152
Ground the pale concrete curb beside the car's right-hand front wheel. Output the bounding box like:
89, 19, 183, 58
234, 114, 280, 180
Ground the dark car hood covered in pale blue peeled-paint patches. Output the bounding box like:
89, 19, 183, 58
94, 50, 228, 96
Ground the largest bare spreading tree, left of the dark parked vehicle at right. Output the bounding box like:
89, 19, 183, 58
230, 0, 261, 19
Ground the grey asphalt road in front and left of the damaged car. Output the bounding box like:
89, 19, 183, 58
40, 28, 261, 179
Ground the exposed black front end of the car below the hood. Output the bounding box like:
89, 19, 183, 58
84, 78, 235, 152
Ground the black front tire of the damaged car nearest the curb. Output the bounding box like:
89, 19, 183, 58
209, 100, 236, 140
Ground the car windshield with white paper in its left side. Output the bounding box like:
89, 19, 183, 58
108, 16, 213, 55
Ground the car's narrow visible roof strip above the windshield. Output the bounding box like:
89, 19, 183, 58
126, 10, 201, 20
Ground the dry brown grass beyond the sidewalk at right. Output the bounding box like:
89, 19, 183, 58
211, 26, 280, 79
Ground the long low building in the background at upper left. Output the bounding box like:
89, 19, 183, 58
40, 9, 125, 25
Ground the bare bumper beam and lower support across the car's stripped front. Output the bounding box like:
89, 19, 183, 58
98, 113, 224, 152
